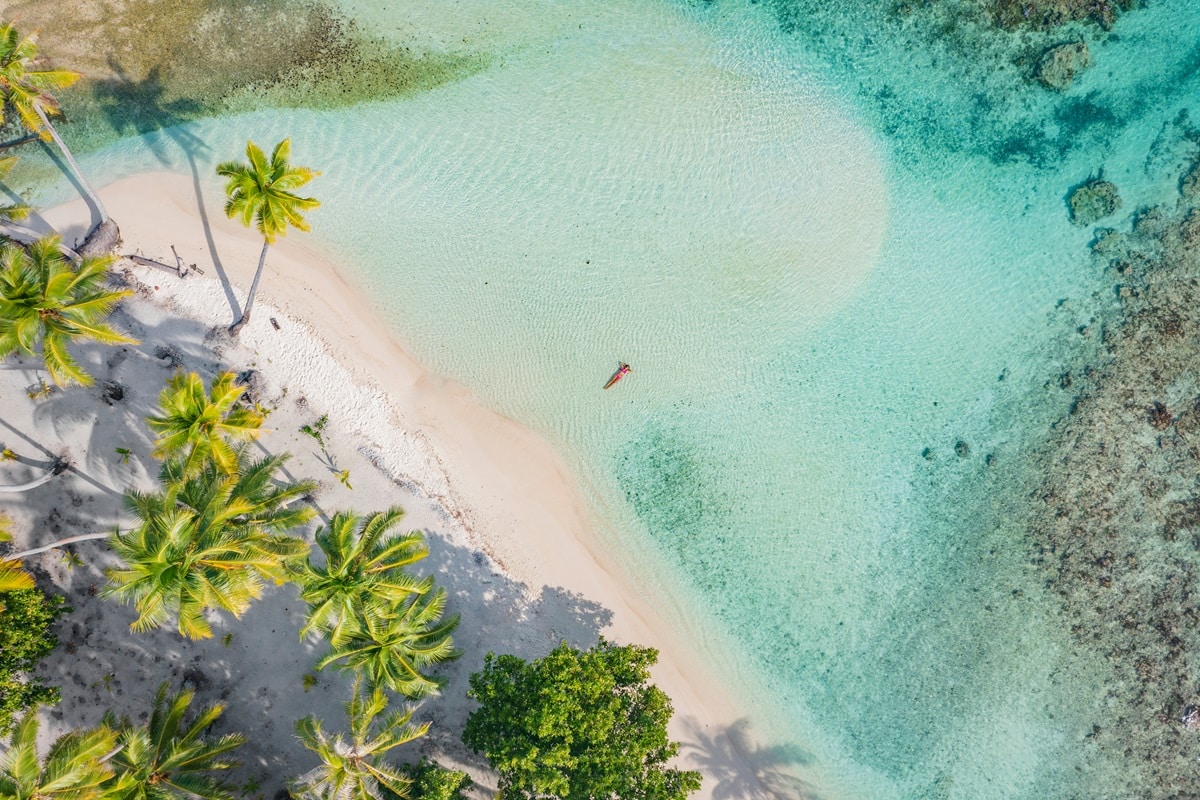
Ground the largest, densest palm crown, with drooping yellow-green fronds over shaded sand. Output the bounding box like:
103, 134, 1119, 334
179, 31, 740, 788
103, 445, 316, 639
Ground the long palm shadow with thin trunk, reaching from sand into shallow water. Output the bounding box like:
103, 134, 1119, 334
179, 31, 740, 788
92, 58, 241, 319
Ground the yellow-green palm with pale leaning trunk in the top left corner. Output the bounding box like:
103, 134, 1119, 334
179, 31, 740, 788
0, 22, 108, 224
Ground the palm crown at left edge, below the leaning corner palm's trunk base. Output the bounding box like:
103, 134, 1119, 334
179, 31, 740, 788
0, 236, 137, 385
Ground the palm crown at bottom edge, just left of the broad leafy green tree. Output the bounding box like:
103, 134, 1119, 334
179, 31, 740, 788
292, 681, 430, 800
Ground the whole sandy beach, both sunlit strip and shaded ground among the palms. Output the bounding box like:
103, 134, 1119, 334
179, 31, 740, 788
0, 174, 806, 799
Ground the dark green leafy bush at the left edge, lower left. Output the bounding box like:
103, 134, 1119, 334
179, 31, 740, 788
0, 589, 70, 733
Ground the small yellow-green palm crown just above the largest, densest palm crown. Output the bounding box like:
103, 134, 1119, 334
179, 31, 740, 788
146, 372, 263, 475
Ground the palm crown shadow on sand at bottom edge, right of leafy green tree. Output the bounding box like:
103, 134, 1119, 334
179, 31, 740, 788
682, 718, 821, 800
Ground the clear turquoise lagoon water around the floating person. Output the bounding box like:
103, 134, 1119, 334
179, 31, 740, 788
30, 0, 1200, 799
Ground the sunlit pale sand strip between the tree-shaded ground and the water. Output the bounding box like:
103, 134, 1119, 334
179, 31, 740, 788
30, 173, 780, 798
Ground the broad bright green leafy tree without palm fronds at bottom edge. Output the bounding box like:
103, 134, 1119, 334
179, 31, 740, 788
462, 639, 700, 800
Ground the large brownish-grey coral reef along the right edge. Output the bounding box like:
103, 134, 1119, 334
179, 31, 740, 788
1031, 143, 1200, 800
